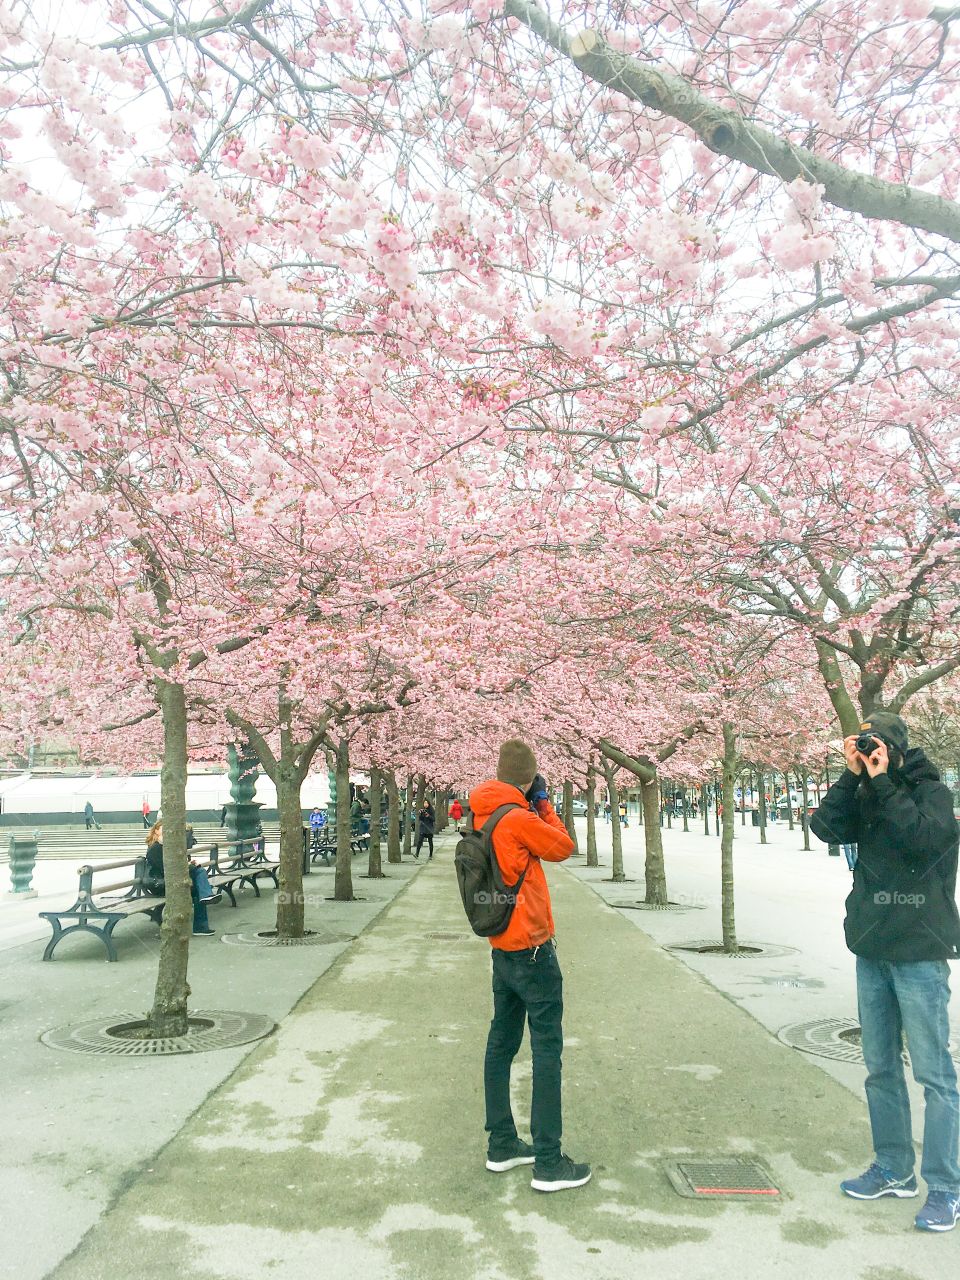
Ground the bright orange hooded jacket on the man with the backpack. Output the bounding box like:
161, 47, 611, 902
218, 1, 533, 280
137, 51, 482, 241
470, 780, 573, 951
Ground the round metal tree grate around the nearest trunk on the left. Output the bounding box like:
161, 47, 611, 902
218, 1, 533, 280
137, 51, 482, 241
40, 1009, 276, 1057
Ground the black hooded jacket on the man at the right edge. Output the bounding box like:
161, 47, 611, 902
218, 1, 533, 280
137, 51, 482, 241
810, 748, 960, 963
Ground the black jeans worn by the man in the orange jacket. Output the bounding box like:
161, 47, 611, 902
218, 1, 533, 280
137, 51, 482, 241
484, 942, 563, 1165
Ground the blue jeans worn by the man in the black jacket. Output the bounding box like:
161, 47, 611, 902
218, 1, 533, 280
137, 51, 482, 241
856, 956, 960, 1196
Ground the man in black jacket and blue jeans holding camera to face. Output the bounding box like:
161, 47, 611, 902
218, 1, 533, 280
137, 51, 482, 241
810, 712, 960, 1231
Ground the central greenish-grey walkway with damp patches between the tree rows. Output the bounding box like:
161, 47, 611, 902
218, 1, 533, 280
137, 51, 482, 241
45, 840, 960, 1280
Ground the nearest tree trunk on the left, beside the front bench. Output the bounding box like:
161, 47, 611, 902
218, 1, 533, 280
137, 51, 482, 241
147, 676, 193, 1037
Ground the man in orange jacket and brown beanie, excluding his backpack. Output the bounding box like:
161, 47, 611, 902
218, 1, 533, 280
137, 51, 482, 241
470, 739, 590, 1192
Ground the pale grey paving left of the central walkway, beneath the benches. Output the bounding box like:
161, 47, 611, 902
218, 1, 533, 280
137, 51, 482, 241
0, 858, 419, 1280
